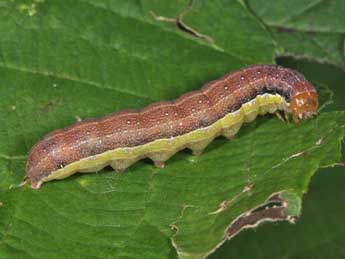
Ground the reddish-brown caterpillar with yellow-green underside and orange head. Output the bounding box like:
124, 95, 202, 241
25, 65, 318, 189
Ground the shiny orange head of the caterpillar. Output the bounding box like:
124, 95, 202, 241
290, 91, 319, 122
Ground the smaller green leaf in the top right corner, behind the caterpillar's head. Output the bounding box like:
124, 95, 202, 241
247, 0, 345, 69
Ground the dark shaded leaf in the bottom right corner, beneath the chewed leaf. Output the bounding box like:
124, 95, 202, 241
209, 167, 345, 259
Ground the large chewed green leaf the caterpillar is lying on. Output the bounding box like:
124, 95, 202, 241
0, 0, 345, 258
